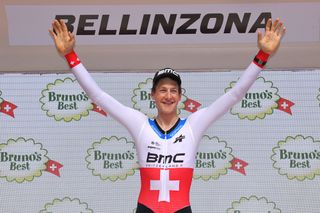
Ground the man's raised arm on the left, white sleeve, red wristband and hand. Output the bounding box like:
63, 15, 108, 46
49, 20, 146, 139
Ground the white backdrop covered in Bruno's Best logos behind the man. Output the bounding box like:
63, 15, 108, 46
0, 70, 320, 213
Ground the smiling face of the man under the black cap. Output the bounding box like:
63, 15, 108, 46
151, 78, 181, 116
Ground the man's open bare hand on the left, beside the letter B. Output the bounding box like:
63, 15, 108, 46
49, 20, 76, 56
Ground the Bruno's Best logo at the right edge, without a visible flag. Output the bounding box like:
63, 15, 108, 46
271, 135, 320, 181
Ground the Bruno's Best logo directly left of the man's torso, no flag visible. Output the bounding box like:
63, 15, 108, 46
86, 136, 138, 181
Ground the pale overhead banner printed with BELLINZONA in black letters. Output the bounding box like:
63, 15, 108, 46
6, 3, 320, 45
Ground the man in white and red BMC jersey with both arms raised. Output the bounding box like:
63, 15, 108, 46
49, 19, 285, 213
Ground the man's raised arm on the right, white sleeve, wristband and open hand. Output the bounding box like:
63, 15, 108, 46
189, 19, 286, 141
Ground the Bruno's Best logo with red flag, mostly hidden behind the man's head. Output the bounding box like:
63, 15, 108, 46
131, 78, 201, 118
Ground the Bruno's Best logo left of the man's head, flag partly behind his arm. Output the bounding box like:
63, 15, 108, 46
39, 78, 106, 122
